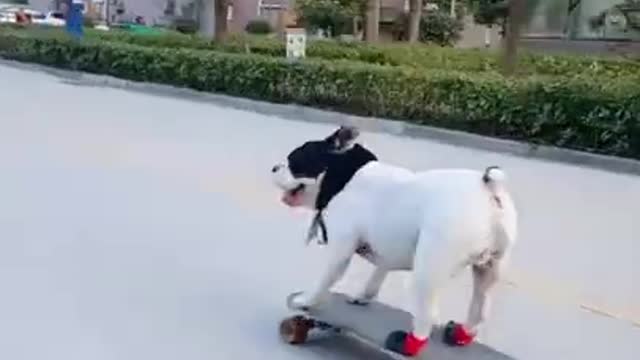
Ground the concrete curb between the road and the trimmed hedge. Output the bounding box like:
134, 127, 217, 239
5, 59, 640, 175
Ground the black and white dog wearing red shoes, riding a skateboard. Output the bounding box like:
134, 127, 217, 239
272, 127, 517, 356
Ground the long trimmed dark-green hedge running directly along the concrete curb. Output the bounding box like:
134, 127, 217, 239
0, 34, 640, 158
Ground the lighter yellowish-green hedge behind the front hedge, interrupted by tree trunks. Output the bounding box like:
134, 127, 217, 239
2, 25, 640, 81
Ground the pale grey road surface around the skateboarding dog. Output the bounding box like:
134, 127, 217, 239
0, 66, 640, 360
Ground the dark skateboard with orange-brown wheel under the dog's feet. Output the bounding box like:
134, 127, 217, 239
279, 292, 514, 360
